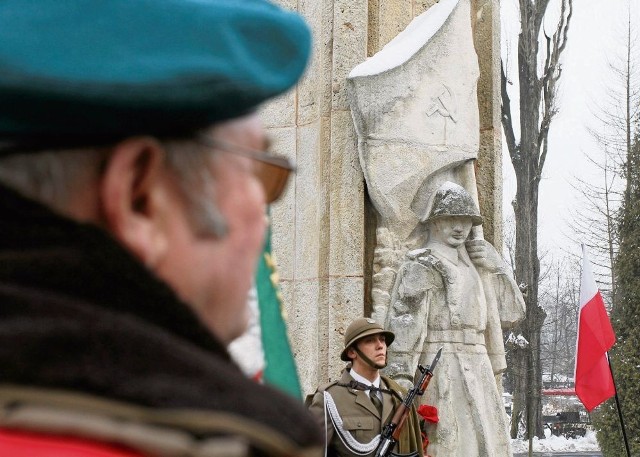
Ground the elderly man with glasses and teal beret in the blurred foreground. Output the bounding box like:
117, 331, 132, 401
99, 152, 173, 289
0, 0, 321, 457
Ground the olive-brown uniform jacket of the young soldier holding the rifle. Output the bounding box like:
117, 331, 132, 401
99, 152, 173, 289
309, 369, 422, 457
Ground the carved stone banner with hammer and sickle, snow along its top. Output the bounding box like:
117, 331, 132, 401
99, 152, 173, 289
347, 0, 481, 322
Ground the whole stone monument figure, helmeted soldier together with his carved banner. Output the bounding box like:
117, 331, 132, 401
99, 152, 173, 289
348, 0, 524, 457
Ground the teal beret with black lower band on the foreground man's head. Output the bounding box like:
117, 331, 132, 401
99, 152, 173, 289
0, 0, 311, 148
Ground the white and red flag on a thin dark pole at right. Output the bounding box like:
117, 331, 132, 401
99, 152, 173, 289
575, 245, 616, 412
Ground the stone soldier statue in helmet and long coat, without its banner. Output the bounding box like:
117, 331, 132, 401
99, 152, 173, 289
385, 182, 524, 457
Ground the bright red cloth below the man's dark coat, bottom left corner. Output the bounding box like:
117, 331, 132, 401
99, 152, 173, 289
0, 428, 148, 457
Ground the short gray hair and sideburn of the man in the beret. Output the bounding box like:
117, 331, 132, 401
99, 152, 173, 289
0, 140, 227, 238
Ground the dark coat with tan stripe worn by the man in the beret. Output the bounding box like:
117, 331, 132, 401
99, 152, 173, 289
0, 183, 322, 456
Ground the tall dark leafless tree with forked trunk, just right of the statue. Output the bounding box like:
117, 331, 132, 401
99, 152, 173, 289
502, 0, 573, 439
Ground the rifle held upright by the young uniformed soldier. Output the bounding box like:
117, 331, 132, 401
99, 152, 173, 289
375, 348, 442, 457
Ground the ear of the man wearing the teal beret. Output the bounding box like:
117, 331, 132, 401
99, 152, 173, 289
99, 137, 168, 267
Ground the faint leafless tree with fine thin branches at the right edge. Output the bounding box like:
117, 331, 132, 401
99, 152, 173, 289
571, 2, 640, 306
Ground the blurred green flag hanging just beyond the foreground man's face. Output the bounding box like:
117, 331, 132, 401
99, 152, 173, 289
256, 223, 302, 399
